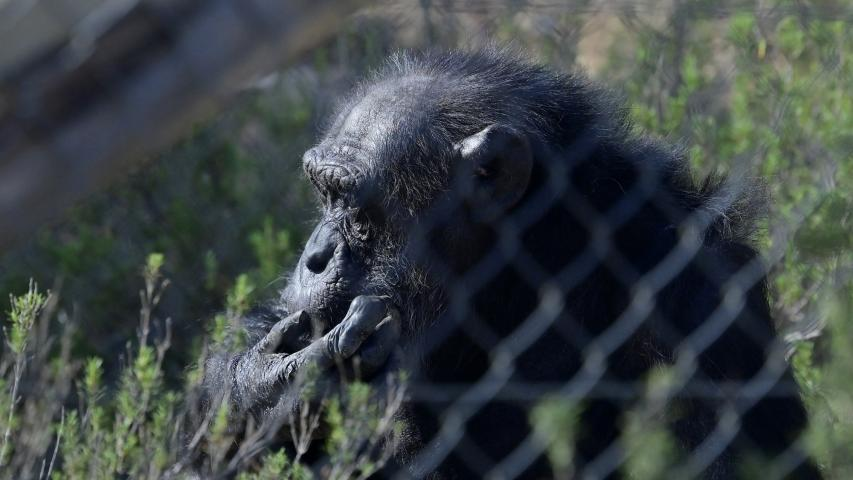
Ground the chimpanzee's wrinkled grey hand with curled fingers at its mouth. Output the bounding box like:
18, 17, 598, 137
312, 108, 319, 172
229, 296, 400, 430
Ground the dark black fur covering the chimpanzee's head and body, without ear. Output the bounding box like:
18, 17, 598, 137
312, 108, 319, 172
195, 50, 819, 478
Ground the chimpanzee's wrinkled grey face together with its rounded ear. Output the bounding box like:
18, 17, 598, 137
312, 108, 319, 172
284, 77, 531, 326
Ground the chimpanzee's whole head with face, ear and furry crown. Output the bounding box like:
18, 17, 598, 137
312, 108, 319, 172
283, 48, 624, 336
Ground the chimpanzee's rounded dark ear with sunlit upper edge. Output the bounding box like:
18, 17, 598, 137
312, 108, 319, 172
454, 124, 533, 218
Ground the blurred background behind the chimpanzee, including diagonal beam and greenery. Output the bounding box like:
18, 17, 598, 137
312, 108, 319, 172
0, 0, 853, 478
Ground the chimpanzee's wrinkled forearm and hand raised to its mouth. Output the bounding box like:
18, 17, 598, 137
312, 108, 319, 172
184, 296, 400, 472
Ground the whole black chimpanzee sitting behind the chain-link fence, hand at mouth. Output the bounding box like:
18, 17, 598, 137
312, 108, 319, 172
193, 48, 820, 478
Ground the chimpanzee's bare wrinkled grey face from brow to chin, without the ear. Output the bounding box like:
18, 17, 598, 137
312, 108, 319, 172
285, 79, 416, 325
